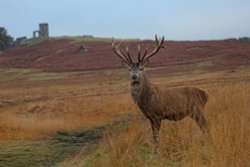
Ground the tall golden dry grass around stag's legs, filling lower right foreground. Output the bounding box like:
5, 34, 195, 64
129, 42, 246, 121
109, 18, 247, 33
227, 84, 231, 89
74, 82, 250, 167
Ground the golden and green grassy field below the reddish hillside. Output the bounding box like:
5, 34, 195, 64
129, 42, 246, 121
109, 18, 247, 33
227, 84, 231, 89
0, 67, 250, 167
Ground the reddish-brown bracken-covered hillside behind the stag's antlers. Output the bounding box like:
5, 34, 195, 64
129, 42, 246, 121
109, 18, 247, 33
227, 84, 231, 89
0, 39, 250, 73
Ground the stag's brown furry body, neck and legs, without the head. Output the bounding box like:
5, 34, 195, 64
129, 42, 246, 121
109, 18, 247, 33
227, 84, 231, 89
131, 73, 208, 151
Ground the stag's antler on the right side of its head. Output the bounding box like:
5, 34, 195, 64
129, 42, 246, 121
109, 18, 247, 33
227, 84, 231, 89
138, 35, 165, 63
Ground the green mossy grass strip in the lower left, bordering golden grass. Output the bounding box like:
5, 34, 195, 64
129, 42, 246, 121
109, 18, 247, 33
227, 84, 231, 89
0, 125, 110, 167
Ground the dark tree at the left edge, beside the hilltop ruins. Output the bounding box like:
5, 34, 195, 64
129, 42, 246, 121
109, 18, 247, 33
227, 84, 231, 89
0, 27, 13, 50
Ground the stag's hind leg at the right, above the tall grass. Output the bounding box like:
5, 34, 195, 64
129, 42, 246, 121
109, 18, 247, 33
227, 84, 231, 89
190, 106, 209, 133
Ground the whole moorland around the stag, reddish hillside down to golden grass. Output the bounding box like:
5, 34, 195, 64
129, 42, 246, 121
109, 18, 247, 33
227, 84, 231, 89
0, 38, 250, 167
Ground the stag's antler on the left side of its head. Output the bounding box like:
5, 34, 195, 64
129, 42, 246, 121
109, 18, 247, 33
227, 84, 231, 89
112, 41, 132, 63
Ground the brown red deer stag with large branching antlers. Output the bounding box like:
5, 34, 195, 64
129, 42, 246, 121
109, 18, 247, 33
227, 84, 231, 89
112, 36, 209, 151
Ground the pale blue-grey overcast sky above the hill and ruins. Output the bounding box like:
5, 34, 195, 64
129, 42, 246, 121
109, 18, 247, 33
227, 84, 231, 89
0, 0, 250, 40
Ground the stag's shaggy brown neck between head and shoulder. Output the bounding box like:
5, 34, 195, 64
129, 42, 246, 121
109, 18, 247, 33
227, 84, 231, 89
131, 74, 150, 105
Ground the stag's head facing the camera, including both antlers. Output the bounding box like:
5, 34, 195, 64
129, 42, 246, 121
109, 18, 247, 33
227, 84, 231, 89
112, 35, 165, 82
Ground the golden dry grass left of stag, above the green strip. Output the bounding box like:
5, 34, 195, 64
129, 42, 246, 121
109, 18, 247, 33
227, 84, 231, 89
0, 81, 134, 140
